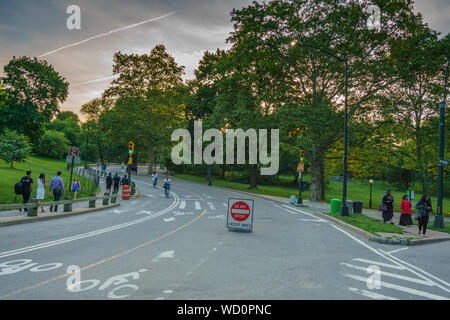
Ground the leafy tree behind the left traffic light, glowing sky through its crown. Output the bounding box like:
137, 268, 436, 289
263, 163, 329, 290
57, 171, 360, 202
103, 45, 185, 172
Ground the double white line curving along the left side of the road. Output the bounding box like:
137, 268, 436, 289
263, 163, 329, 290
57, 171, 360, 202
0, 193, 179, 259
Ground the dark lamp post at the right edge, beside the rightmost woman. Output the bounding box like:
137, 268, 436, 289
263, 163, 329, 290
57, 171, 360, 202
434, 61, 450, 228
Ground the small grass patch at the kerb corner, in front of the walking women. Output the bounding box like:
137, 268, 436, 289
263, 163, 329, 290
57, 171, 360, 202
325, 212, 403, 236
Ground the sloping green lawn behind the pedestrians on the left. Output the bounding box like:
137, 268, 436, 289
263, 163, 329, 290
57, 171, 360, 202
0, 157, 100, 204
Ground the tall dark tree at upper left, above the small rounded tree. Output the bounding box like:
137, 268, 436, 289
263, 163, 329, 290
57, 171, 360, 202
0, 57, 69, 145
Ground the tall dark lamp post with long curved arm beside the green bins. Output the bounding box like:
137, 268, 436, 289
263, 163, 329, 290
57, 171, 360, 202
291, 40, 348, 216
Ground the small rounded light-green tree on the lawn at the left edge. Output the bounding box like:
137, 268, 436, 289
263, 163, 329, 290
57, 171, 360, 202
0, 130, 31, 168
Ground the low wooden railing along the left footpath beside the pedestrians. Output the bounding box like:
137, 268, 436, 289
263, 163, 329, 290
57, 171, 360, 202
0, 193, 119, 217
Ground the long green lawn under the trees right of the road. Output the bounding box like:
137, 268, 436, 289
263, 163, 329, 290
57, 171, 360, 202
176, 173, 450, 217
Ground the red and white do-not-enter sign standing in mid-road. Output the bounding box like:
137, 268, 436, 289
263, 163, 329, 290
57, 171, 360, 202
227, 198, 253, 230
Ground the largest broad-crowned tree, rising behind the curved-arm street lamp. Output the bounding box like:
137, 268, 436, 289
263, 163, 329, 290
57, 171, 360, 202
228, 0, 426, 201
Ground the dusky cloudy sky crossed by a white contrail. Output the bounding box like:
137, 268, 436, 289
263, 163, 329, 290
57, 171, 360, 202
0, 0, 450, 120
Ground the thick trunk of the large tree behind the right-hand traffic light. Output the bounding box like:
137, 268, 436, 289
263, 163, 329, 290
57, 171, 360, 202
309, 148, 325, 201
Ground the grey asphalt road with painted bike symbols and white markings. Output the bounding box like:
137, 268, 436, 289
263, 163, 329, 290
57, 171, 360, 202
0, 170, 450, 300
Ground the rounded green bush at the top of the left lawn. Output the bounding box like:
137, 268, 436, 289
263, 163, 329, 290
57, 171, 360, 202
37, 130, 70, 159
